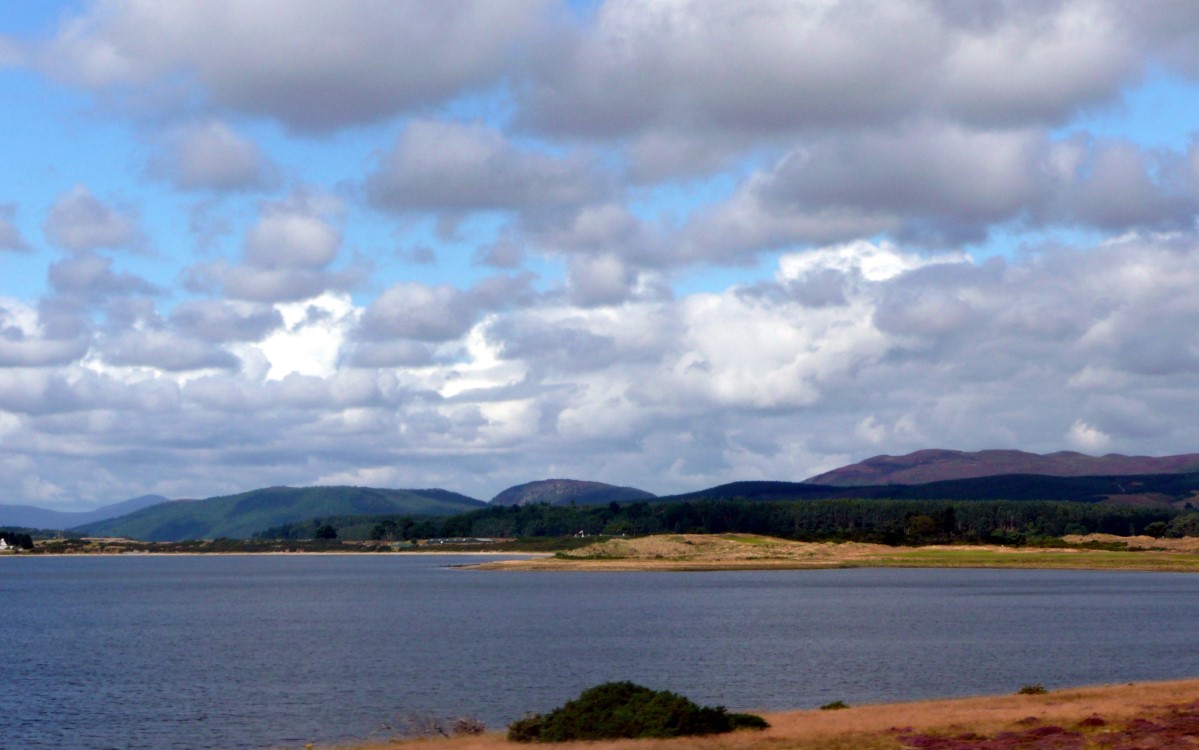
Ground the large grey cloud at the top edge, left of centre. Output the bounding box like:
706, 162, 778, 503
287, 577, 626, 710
42, 0, 546, 133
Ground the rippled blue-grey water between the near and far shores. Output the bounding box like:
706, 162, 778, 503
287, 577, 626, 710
0, 556, 1199, 748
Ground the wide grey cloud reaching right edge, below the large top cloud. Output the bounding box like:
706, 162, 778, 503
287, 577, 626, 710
690, 123, 1199, 255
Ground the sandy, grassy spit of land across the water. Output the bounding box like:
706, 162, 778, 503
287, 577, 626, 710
472, 534, 1199, 573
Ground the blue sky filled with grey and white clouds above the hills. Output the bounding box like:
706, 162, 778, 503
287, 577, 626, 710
0, 0, 1199, 510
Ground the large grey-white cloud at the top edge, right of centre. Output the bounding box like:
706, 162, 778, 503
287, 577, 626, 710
520, 0, 1162, 138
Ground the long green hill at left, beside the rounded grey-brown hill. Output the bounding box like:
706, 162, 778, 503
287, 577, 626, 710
76, 486, 487, 542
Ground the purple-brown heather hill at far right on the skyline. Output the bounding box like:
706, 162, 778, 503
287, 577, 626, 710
805, 450, 1199, 486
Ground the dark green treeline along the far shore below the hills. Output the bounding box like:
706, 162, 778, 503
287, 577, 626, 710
255, 500, 1199, 544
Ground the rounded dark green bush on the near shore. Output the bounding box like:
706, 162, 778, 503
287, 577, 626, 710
508, 682, 770, 742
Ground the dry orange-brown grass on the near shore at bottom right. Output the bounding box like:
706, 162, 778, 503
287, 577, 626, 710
330, 679, 1199, 750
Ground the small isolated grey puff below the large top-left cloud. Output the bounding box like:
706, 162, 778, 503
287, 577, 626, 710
146, 120, 275, 192
